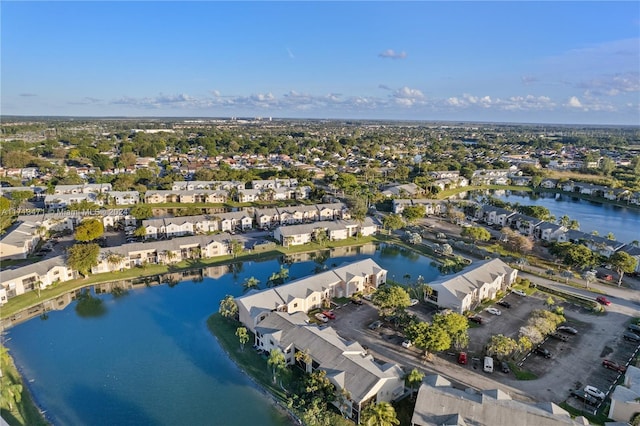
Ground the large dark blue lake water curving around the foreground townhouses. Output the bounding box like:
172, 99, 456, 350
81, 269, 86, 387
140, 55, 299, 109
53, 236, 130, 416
4, 245, 439, 426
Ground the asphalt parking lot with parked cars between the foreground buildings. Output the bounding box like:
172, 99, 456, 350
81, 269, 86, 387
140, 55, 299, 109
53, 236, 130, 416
329, 293, 638, 411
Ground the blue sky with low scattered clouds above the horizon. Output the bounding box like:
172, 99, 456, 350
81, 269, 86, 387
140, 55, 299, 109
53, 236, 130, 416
0, 1, 640, 125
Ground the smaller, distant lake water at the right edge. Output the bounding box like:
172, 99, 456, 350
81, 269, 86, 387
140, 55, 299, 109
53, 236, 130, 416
475, 191, 640, 243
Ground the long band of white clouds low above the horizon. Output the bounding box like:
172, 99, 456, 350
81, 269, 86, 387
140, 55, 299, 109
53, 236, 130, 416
101, 85, 637, 116
